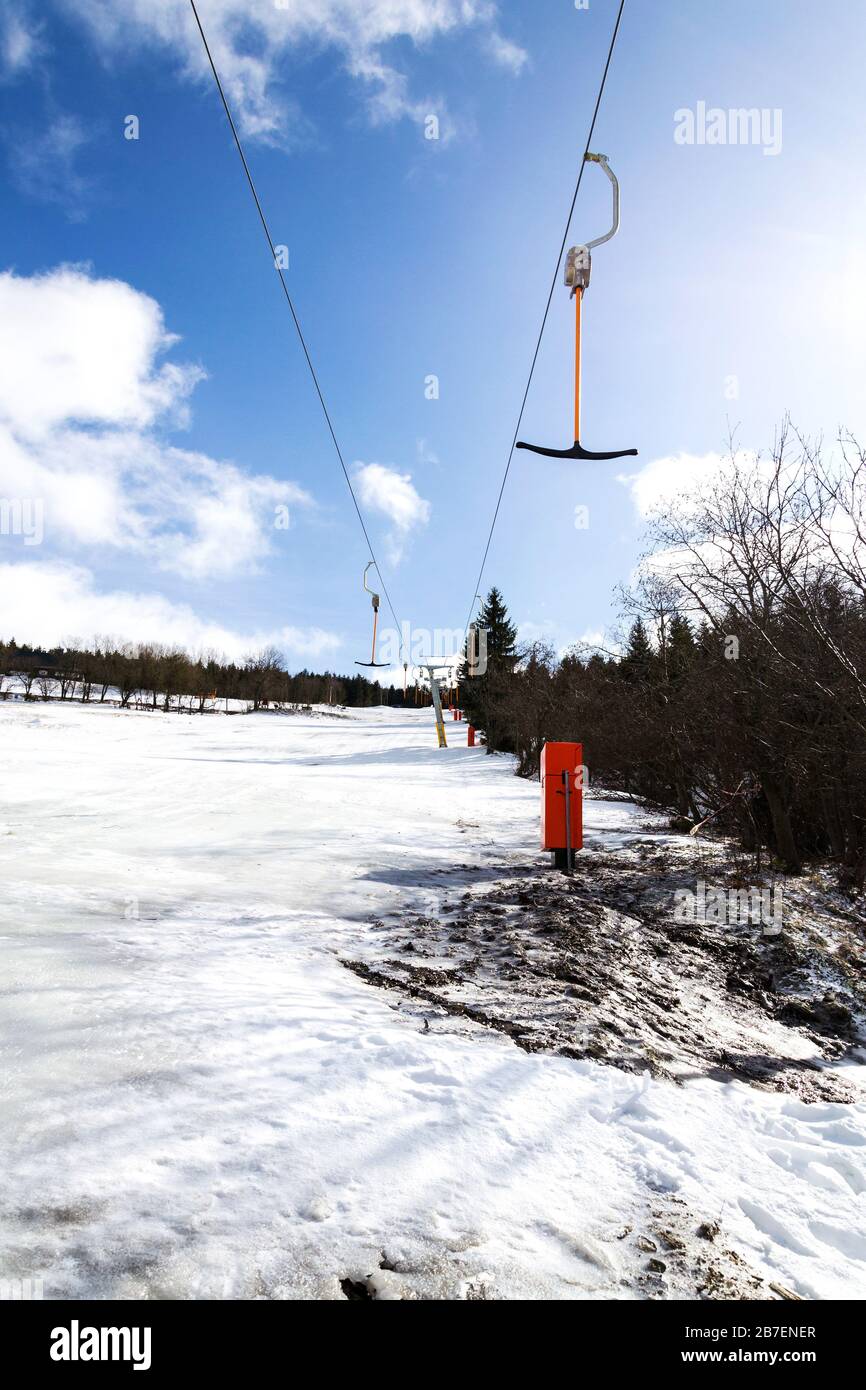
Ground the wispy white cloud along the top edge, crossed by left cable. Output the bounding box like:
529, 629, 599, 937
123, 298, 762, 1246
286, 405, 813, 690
63, 0, 525, 143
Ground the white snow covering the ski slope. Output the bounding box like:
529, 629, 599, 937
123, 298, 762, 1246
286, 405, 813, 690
0, 703, 866, 1298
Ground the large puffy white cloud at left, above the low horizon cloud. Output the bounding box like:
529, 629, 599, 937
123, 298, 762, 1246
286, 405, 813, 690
0, 267, 314, 580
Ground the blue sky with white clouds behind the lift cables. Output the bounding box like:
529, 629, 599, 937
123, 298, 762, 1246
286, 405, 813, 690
0, 0, 866, 670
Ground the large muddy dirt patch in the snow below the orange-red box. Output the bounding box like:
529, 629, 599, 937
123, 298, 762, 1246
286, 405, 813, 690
345, 840, 866, 1100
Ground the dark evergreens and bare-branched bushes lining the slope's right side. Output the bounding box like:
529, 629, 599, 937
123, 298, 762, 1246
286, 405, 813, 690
461, 427, 866, 890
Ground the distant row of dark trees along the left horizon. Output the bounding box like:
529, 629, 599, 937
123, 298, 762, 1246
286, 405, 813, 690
0, 638, 421, 713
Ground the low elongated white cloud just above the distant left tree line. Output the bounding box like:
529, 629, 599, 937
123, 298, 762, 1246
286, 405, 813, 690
0, 562, 341, 664
